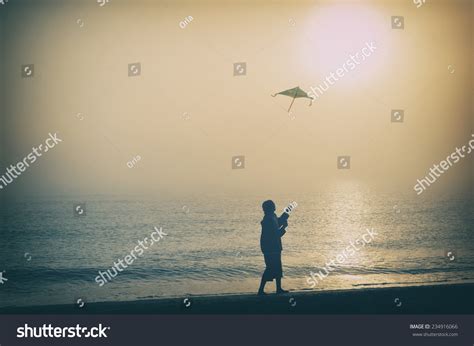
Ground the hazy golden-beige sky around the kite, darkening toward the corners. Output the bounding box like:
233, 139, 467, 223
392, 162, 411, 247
0, 0, 474, 194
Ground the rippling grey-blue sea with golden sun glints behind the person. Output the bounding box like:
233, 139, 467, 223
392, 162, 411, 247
0, 188, 474, 307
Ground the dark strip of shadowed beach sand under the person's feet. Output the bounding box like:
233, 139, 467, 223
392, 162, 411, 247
0, 284, 474, 314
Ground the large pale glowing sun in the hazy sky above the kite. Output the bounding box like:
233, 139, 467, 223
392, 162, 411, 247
300, 3, 390, 84
